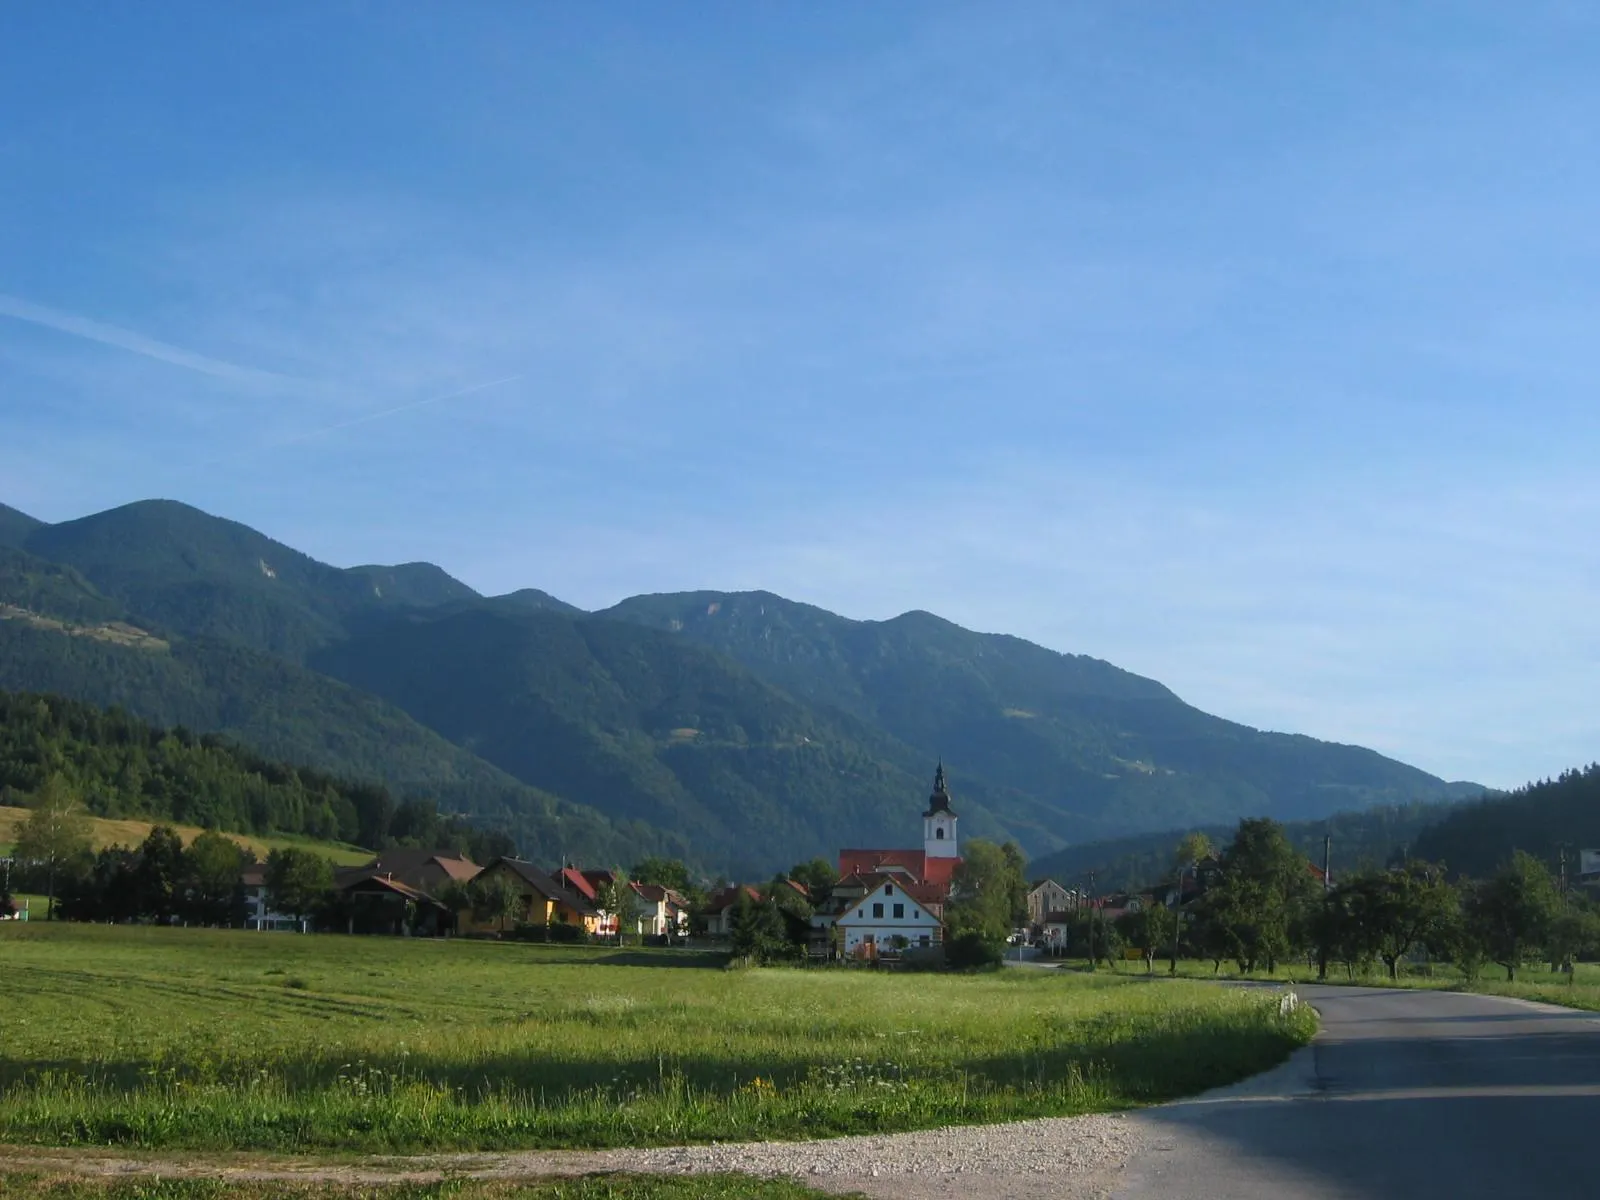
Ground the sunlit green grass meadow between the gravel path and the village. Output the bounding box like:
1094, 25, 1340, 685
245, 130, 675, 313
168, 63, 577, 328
0, 923, 1314, 1150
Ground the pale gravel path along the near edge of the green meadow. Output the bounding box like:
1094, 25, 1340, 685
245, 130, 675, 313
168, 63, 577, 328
0, 1114, 1138, 1200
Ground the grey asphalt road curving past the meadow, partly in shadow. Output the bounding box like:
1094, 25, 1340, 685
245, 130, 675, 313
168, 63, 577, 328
1112, 986, 1600, 1200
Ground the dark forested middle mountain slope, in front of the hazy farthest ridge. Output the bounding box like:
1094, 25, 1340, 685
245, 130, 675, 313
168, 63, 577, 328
312, 610, 1005, 870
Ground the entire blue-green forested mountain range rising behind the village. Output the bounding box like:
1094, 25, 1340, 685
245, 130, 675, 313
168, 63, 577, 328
0, 501, 1482, 874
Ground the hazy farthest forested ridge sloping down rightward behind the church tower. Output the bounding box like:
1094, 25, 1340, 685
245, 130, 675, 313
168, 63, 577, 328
600, 592, 1474, 835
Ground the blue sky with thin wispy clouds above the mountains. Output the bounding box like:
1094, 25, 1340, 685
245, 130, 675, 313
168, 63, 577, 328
0, 2, 1600, 784
